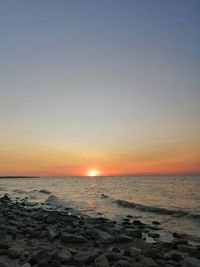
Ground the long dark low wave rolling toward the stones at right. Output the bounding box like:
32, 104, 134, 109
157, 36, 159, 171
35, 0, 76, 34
101, 194, 200, 220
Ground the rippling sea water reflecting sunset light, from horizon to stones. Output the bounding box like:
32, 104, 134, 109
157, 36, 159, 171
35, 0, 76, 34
0, 176, 200, 243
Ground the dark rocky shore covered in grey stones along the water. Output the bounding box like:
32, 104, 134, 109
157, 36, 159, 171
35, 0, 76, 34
0, 195, 200, 267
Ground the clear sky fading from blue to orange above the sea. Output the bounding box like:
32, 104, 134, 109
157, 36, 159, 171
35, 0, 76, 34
0, 0, 200, 176
